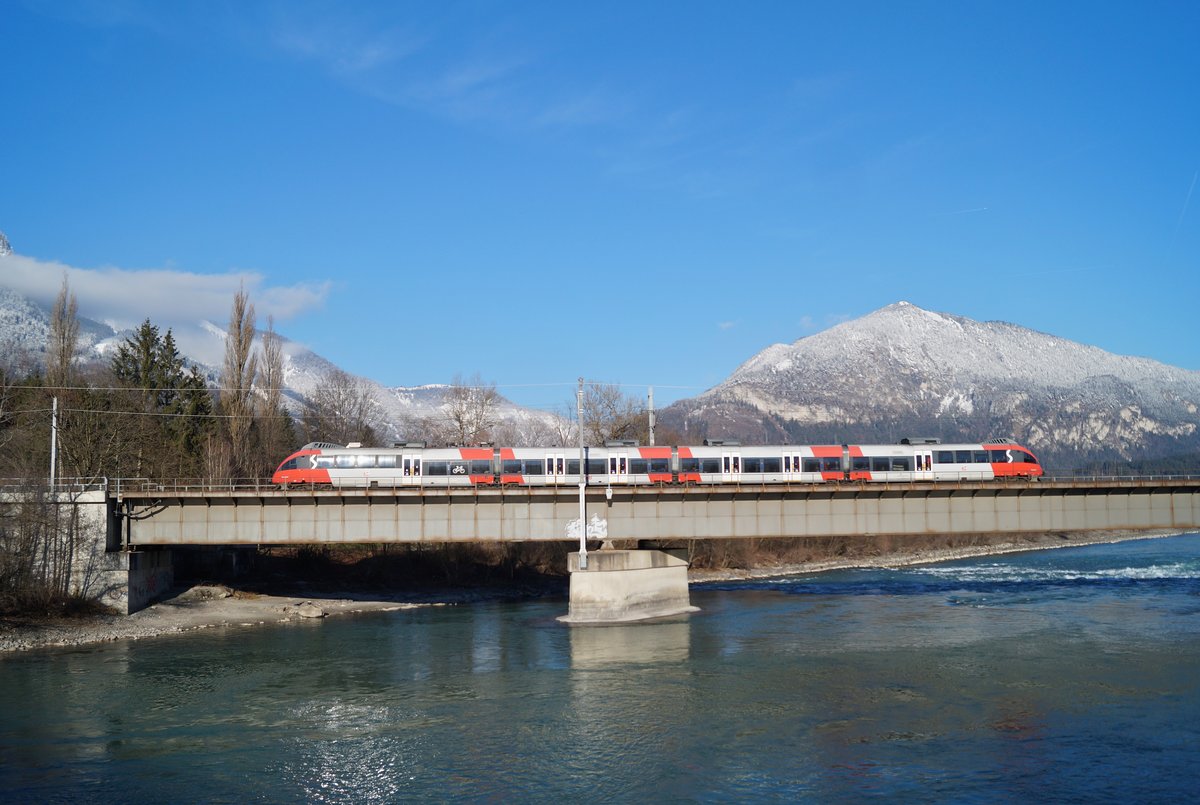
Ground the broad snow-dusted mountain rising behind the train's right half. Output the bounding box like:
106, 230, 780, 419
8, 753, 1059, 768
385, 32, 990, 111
659, 302, 1200, 465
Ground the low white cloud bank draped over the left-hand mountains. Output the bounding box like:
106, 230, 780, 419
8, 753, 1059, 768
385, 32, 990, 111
0, 254, 330, 329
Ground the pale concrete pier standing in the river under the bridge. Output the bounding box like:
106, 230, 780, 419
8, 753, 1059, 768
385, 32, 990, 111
559, 549, 700, 625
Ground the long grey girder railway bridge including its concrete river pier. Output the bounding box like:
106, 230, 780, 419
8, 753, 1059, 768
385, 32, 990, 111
107, 477, 1200, 623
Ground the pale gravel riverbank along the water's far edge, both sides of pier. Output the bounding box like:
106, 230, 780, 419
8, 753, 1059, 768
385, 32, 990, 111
0, 530, 1187, 656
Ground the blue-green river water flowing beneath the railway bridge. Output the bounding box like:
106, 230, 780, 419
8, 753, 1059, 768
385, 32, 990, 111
0, 534, 1200, 803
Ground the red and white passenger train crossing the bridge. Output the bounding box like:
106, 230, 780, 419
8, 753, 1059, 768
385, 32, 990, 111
271, 439, 1043, 487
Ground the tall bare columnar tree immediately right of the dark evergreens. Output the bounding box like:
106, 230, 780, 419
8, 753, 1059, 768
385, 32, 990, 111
221, 288, 258, 475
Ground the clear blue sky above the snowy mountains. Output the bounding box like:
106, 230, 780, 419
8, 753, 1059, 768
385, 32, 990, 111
0, 0, 1200, 408
